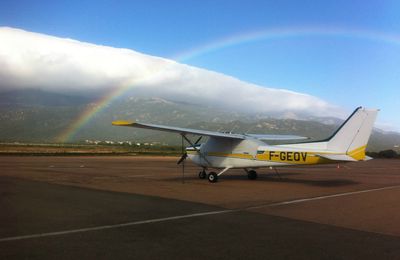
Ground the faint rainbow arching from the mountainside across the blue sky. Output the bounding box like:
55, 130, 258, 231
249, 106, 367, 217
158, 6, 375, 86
56, 27, 400, 143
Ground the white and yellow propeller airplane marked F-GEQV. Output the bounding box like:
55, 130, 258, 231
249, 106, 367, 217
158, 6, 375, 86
112, 107, 379, 183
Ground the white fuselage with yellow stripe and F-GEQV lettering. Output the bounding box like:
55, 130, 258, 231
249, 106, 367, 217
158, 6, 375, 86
187, 137, 354, 168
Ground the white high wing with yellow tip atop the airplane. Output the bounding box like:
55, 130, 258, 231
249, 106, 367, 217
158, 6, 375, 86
112, 121, 308, 141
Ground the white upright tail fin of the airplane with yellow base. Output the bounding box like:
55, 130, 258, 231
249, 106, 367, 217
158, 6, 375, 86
328, 107, 379, 160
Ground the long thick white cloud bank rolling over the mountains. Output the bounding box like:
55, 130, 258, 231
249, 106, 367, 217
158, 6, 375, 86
0, 27, 342, 116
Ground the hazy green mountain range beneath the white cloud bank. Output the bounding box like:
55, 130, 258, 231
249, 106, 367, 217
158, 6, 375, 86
0, 90, 400, 151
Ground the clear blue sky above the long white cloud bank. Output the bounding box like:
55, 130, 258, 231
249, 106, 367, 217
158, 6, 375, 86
0, 0, 400, 131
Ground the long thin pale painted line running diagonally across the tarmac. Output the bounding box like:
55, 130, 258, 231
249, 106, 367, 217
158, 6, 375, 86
0, 185, 400, 242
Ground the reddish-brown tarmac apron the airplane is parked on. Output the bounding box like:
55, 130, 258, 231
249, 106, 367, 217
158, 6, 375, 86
0, 156, 400, 259
